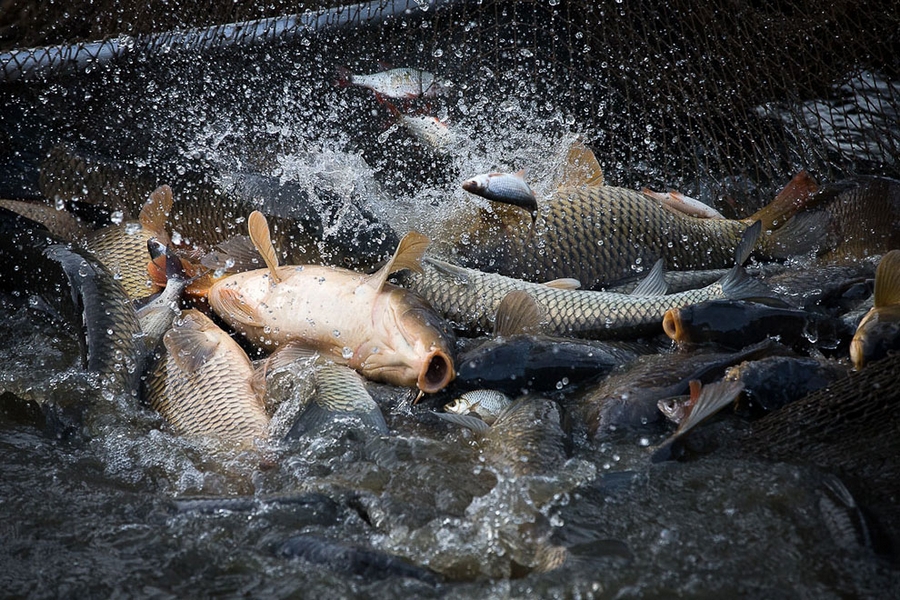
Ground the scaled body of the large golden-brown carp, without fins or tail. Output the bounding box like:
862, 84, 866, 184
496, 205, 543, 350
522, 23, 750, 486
454, 186, 748, 289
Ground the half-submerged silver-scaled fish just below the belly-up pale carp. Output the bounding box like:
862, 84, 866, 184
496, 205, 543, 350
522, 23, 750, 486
286, 363, 388, 439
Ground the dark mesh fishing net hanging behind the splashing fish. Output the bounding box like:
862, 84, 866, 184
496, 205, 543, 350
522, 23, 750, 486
0, 0, 900, 216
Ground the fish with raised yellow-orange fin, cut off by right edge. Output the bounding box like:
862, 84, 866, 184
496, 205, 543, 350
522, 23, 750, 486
850, 250, 900, 369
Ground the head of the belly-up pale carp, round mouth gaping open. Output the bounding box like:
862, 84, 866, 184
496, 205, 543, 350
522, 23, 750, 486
351, 286, 456, 393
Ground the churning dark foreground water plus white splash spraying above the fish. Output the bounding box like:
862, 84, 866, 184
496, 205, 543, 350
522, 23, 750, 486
0, 3, 900, 598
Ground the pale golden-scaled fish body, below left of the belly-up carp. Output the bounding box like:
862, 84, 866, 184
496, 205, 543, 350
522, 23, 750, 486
143, 309, 269, 445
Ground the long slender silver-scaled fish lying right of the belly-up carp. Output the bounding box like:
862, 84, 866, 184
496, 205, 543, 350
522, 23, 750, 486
404, 219, 768, 339
